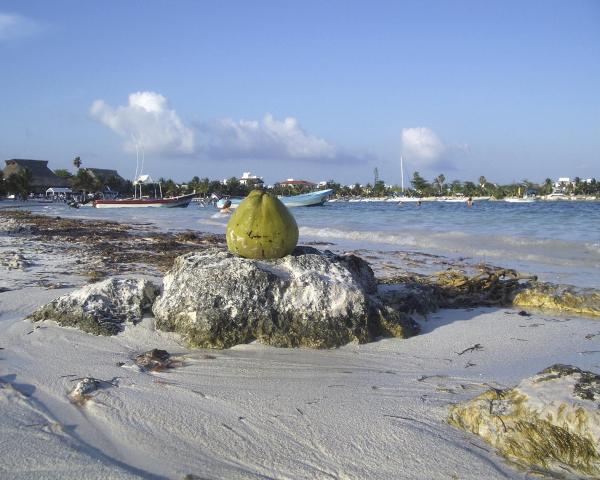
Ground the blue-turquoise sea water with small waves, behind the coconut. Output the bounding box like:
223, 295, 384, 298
18, 201, 600, 287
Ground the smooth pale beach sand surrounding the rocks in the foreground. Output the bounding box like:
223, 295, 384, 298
0, 232, 600, 479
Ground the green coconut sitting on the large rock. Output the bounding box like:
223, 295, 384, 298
227, 190, 298, 259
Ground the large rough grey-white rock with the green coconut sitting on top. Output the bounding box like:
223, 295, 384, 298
152, 247, 416, 348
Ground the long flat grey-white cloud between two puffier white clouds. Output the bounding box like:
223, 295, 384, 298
199, 114, 343, 161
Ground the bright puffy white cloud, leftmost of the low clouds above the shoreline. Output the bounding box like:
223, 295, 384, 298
90, 92, 195, 154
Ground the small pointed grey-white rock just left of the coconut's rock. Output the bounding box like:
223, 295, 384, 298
29, 278, 158, 335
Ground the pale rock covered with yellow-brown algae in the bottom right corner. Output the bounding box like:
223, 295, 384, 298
449, 364, 600, 478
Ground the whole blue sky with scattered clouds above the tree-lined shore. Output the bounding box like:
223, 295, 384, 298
0, 0, 600, 184
